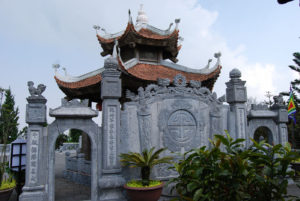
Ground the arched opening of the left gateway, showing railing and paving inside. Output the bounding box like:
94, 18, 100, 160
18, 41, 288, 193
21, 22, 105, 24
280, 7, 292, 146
54, 129, 91, 201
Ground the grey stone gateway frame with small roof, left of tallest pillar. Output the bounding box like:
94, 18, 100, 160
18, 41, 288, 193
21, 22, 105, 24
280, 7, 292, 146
46, 100, 101, 201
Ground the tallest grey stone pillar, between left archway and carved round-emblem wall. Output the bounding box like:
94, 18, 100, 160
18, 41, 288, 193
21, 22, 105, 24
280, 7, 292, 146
99, 57, 125, 201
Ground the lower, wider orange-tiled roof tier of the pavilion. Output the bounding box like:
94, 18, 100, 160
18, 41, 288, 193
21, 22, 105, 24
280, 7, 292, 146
54, 53, 222, 102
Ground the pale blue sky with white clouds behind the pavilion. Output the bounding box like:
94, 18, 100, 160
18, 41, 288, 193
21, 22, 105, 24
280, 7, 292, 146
0, 0, 300, 127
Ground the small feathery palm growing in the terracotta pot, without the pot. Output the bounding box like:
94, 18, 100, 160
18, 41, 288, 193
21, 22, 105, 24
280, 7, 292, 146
120, 147, 173, 186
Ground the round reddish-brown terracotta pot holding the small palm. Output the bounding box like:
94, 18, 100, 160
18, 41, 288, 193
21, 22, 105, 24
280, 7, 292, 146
124, 182, 164, 201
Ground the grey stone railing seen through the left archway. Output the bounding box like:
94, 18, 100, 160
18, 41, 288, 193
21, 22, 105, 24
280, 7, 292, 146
64, 152, 91, 185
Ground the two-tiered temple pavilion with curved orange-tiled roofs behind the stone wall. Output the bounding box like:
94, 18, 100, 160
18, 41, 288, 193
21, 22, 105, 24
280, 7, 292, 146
54, 6, 222, 110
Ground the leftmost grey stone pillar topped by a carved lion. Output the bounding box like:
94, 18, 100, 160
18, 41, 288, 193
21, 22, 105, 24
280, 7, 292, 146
19, 85, 48, 201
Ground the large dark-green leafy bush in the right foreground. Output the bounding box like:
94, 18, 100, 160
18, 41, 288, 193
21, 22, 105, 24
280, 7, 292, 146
170, 132, 299, 201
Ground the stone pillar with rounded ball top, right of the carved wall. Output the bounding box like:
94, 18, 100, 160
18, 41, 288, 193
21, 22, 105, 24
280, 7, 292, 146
226, 69, 249, 145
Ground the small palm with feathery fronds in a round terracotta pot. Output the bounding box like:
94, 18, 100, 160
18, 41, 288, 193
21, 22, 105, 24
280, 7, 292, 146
120, 147, 173, 201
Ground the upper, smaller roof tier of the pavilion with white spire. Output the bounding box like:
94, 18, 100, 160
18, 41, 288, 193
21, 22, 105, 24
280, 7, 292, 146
97, 8, 180, 62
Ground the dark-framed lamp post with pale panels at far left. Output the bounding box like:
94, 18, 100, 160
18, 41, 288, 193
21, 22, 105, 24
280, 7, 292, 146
10, 138, 26, 200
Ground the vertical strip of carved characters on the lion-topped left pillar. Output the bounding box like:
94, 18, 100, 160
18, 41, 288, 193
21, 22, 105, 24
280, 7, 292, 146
29, 131, 39, 184
